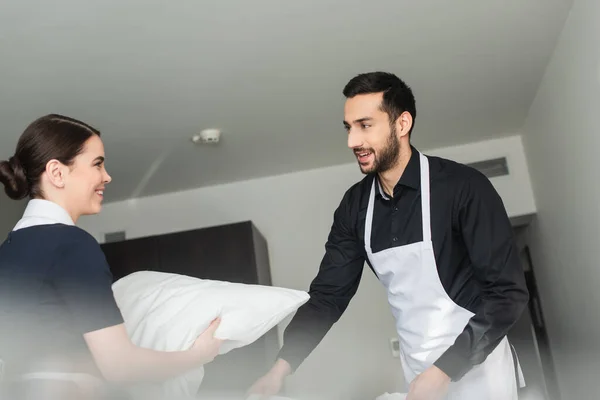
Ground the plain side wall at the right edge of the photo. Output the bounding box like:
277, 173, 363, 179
523, 0, 600, 399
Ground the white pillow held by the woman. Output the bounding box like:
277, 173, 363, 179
113, 271, 309, 396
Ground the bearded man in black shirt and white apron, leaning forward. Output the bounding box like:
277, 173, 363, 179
250, 72, 529, 400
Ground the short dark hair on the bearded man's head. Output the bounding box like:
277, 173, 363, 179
343, 72, 417, 137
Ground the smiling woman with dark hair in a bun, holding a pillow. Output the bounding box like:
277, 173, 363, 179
0, 114, 220, 396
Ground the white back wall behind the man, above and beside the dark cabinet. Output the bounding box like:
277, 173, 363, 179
81, 136, 535, 400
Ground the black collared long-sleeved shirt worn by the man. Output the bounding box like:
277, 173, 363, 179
279, 147, 529, 381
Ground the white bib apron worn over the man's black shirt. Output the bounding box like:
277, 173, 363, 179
365, 154, 522, 400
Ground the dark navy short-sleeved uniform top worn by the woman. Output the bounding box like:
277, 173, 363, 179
0, 224, 123, 378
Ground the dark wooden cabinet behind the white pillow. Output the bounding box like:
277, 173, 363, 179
102, 221, 279, 394
